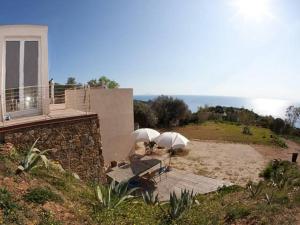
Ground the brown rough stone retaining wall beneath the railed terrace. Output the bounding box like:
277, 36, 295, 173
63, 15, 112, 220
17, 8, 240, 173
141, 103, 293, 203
4, 115, 105, 182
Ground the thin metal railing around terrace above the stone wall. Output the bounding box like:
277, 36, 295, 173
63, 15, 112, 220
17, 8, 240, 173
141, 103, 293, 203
0, 82, 95, 125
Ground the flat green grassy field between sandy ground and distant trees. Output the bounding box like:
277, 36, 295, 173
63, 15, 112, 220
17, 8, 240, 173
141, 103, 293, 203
174, 122, 281, 145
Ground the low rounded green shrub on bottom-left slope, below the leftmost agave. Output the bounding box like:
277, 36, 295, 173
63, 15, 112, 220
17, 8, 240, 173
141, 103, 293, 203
24, 187, 63, 204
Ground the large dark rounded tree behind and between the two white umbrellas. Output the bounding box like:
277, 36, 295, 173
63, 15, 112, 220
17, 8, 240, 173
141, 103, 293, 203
151, 95, 191, 127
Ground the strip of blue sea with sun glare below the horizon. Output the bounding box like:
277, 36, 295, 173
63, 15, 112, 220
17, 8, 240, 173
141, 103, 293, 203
134, 95, 300, 127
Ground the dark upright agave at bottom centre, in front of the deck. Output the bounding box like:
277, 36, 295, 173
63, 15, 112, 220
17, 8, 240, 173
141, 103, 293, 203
160, 190, 199, 220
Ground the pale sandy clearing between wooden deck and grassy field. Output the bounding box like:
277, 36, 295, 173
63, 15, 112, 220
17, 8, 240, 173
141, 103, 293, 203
139, 141, 300, 185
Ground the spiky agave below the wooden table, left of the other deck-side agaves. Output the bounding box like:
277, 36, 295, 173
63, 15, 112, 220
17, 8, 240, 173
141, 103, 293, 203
96, 180, 138, 209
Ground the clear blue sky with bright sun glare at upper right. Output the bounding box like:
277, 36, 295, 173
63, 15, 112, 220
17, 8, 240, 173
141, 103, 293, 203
0, 0, 300, 100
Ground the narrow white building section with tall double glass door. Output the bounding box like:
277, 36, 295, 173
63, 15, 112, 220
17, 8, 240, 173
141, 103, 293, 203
0, 25, 49, 119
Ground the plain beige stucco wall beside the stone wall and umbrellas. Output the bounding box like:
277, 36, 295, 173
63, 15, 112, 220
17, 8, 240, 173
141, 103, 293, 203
66, 88, 134, 163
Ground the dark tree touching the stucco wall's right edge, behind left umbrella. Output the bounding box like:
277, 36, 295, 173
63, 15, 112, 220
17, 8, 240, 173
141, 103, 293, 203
133, 100, 157, 128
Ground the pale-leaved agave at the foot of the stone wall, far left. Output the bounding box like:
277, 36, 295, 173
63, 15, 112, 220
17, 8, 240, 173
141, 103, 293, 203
16, 139, 51, 174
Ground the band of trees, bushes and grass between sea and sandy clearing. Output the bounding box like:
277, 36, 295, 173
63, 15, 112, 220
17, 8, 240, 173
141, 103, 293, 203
134, 95, 300, 148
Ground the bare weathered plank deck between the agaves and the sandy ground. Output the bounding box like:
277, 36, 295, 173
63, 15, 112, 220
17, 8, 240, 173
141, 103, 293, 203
156, 168, 232, 201
